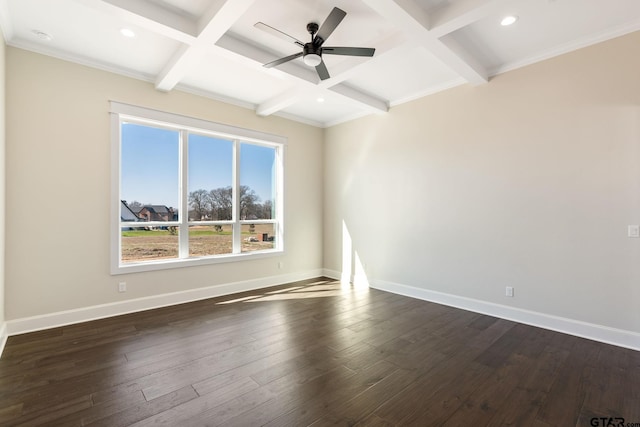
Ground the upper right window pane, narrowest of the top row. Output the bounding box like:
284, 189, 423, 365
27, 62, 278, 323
240, 143, 276, 220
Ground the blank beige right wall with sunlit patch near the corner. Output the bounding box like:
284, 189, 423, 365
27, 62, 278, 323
324, 32, 640, 332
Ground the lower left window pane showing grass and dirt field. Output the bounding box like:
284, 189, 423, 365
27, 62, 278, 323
121, 226, 179, 264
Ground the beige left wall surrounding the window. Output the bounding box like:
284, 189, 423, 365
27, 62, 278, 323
6, 48, 323, 320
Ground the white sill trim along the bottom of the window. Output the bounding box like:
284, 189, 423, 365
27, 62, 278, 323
111, 249, 284, 276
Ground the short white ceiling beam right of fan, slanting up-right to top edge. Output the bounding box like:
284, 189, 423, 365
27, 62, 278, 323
430, 0, 514, 37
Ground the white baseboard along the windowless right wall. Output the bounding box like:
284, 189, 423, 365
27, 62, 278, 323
323, 269, 640, 351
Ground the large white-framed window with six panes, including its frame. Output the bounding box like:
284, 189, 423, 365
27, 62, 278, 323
111, 102, 286, 274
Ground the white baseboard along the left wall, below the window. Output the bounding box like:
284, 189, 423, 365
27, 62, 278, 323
1, 269, 322, 338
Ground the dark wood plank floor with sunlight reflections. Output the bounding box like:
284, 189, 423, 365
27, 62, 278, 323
0, 279, 640, 427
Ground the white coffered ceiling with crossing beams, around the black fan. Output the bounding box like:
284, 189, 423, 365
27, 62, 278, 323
0, 0, 640, 127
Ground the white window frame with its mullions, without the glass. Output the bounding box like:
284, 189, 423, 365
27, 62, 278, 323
110, 101, 287, 275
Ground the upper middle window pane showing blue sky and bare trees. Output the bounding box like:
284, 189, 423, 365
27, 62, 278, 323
188, 134, 233, 221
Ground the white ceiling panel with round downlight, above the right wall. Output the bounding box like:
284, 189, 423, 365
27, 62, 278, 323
453, 0, 640, 74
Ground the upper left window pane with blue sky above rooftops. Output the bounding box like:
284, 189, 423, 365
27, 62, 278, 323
120, 123, 180, 217
